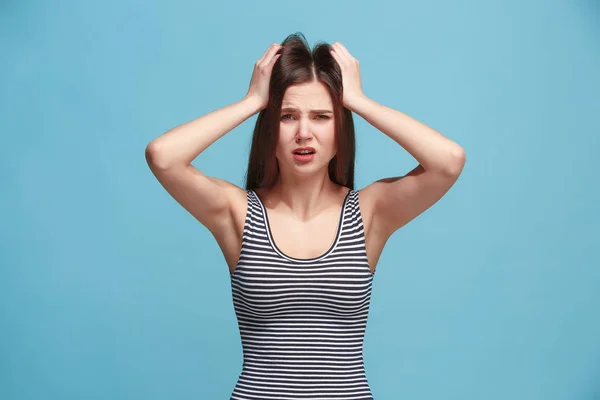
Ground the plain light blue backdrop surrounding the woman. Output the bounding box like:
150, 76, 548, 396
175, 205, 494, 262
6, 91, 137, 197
0, 0, 600, 400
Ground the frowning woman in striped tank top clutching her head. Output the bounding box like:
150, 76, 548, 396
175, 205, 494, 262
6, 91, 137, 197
146, 34, 465, 399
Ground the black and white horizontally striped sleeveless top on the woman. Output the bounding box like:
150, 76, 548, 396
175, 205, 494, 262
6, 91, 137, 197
230, 189, 374, 400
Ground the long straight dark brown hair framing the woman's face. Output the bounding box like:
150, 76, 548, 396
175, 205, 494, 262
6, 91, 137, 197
246, 32, 356, 190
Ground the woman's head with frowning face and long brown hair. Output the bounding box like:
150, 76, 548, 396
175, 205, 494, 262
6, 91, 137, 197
246, 33, 355, 189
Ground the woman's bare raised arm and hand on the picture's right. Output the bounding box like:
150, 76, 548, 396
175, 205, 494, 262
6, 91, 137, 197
330, 42, 465, 238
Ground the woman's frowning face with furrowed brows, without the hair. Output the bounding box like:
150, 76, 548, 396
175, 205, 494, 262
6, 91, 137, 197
275, 82, 336, 175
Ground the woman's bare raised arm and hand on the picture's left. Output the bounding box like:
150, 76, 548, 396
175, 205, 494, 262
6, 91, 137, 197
145, 44, 279, 233
